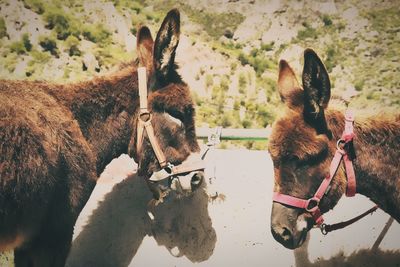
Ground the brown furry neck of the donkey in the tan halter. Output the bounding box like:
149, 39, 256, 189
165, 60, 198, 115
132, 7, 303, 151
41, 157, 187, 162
48, 66, 139, 175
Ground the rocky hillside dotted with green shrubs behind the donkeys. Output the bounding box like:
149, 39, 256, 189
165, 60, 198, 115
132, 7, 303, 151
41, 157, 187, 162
0, 0, 400, 150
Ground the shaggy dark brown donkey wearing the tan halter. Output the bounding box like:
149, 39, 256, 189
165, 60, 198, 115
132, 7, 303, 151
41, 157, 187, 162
0, 10, 202, 266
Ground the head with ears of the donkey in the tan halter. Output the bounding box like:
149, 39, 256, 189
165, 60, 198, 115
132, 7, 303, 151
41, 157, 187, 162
129, 9, 204, 199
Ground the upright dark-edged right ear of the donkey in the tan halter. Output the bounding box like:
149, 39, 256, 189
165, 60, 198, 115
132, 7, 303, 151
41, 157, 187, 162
154, 9, 180, 78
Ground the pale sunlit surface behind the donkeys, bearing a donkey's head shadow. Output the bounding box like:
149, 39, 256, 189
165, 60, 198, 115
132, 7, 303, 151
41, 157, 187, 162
67, 150, 400, 266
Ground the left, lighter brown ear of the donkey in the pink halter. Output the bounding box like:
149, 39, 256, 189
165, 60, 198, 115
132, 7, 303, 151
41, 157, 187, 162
278, 60, 303, 110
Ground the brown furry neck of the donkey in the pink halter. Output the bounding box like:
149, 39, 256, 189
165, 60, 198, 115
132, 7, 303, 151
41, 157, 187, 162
326, 111, 400, 222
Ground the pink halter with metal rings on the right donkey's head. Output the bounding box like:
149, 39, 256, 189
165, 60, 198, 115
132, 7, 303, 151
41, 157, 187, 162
272, 111, 356, 225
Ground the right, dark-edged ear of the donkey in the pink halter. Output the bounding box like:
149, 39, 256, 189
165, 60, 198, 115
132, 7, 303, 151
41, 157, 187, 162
303, 49, 331, 136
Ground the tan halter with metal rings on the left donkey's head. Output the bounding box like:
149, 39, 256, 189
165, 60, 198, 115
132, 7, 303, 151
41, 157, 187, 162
136, 67, 205, 185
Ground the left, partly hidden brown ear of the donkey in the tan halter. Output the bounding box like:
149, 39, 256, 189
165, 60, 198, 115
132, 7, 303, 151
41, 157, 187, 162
136, 26, 154, 70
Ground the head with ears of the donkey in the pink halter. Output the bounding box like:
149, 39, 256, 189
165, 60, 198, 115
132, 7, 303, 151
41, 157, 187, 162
269, 49, 345, 249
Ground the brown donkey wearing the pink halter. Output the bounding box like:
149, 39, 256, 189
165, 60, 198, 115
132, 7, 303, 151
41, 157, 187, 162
269, 49, 400, 249
